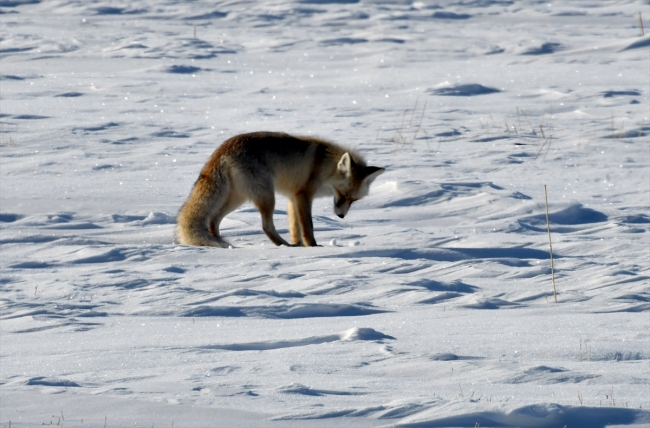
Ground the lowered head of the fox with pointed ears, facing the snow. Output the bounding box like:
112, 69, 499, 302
333, 153, 385, 218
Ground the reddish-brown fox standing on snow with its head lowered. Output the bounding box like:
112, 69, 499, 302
176, 132, 385, 248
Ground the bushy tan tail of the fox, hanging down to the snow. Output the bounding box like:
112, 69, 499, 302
176, 167, 230, 248
